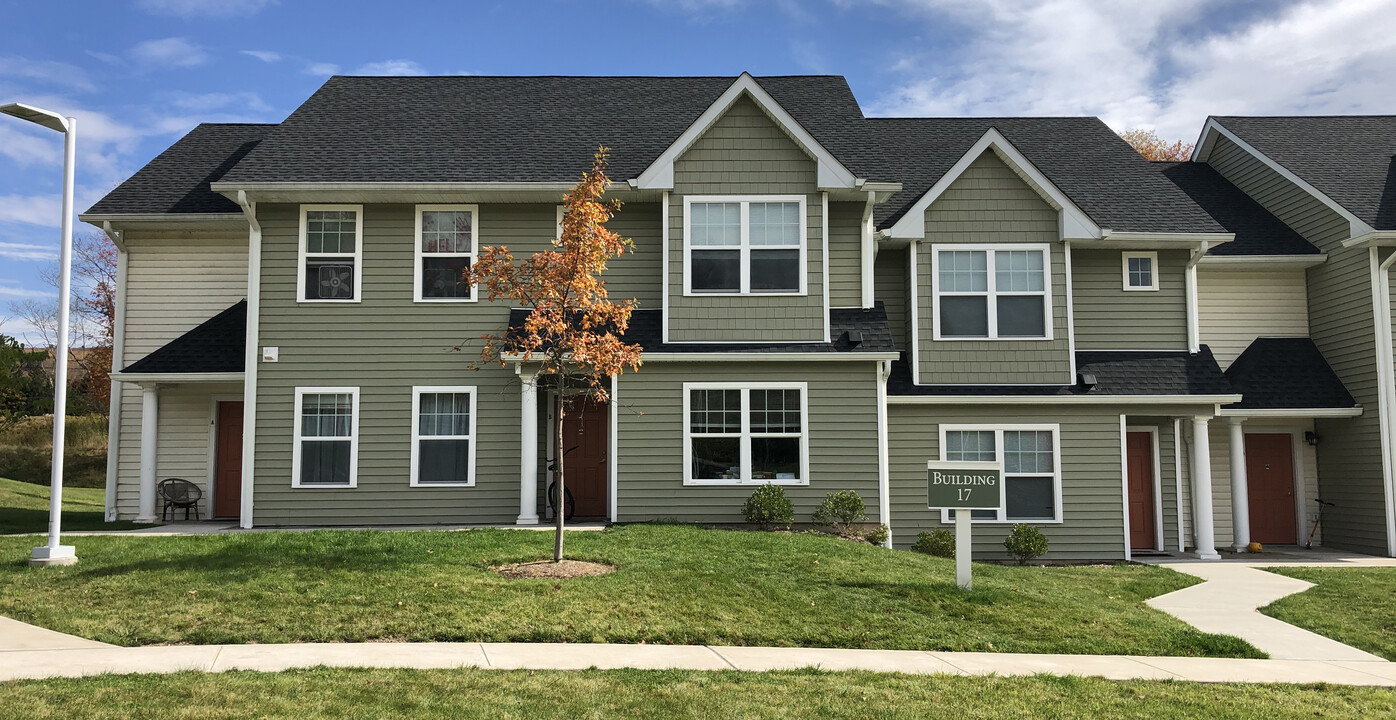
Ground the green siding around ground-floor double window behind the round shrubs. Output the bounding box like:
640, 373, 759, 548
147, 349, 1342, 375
616, 361, 878, 523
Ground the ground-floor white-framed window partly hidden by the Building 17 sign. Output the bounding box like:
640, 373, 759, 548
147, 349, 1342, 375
941, 426, 1061, 522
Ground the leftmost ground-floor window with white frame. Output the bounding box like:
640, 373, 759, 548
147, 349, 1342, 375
292, 388, 359, 487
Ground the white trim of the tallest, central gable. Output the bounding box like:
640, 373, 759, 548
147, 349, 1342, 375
631, 73, 861, 190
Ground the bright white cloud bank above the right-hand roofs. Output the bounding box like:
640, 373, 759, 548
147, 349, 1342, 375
870, 0, 1396, 140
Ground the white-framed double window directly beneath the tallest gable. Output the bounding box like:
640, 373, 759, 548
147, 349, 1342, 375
684, 195, 805, 294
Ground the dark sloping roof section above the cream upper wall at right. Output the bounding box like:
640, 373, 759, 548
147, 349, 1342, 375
1152, 162, 1319, 255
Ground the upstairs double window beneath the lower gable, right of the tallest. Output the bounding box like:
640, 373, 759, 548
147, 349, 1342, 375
931, 244, 1051, 340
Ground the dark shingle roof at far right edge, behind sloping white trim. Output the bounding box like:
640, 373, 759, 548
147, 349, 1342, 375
1213, 114, 1396, 230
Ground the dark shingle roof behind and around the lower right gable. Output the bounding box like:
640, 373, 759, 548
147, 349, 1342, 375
868, 117, 1226, 233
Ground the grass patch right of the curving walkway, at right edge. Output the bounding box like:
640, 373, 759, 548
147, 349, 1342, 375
1261, 568, 1396, 660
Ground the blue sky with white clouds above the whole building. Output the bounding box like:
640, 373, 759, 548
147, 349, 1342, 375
0, 0, 1396, 343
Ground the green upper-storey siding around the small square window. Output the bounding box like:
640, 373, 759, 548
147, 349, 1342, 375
1071, 248, 1188, 350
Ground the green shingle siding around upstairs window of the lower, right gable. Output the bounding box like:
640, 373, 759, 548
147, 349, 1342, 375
916, 152, 1072, 385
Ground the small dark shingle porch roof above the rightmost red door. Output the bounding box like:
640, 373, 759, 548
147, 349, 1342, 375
1226, 338, 1357, 410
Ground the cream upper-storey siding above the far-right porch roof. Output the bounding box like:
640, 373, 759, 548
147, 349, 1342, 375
1198, 265, 1309, 370
